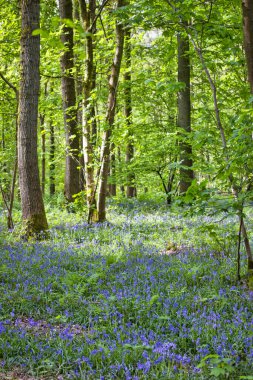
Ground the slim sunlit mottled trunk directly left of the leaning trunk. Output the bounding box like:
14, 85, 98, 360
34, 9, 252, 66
79, 0, 97, 223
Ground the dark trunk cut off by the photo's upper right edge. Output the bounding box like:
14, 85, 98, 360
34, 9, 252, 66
242, 0, 253, 94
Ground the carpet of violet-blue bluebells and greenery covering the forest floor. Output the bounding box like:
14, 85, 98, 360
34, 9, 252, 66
0, 200, 253, 380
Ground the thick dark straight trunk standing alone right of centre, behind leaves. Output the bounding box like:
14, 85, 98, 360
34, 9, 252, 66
177, 30, 194, 194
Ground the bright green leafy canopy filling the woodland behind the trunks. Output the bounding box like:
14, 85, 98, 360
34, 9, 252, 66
0, 0, 250, 212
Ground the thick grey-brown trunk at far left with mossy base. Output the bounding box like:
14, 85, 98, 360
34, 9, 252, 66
18, 0, 48, 239
